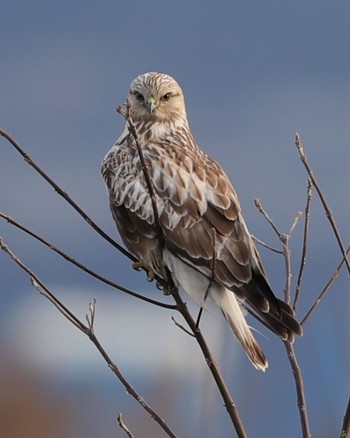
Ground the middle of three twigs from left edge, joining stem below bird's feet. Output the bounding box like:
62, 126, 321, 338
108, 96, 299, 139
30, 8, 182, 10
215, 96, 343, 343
0, 211, 176, 310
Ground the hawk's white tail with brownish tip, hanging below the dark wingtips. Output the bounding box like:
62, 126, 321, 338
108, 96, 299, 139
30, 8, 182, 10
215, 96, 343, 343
210, 285, 268, 371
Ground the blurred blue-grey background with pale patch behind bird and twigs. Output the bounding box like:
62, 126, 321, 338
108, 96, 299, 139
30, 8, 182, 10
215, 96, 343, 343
0, 0, 350, 438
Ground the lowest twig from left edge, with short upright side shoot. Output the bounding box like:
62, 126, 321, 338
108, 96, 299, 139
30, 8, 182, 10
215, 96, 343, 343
0, 238, 176, 438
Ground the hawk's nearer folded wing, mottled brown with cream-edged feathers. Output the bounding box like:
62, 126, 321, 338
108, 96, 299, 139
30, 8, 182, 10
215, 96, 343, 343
141, 144, 279, 313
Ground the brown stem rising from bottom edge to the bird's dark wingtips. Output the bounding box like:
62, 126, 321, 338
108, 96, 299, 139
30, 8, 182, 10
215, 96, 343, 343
284, 341, 311, 438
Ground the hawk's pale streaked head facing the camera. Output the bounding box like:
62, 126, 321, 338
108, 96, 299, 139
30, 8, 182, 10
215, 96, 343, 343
128, 72, 187, 124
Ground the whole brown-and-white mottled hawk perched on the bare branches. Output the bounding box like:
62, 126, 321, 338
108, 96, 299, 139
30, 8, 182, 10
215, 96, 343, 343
101, 72, 302, 371
